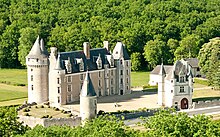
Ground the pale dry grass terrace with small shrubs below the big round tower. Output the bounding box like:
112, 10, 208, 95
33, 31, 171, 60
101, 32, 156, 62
18, 105, 70, 118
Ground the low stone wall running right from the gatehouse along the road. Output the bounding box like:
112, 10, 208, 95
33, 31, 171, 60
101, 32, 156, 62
192, 99, 220, 109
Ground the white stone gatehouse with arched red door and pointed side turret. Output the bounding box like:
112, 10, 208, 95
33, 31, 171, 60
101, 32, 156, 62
158, 60, 193, 109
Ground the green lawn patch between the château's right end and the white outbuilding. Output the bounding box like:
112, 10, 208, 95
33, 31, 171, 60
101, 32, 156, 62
131, 72, 150, 87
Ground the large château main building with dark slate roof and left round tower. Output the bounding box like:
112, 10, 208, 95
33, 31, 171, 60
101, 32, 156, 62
26, 37, 131, 105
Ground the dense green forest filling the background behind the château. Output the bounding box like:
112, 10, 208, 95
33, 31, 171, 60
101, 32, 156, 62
0, 0, 220, 70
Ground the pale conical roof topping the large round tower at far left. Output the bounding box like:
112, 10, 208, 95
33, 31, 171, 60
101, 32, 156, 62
27, 36, 47, 58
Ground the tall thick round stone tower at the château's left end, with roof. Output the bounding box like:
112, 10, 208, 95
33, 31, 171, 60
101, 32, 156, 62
26, 36, 49, 103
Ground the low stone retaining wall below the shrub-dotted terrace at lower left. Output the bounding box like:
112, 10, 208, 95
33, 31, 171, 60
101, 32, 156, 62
18, 115, 81, 128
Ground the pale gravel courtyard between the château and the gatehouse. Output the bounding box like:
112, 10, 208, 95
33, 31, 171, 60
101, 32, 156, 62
62, 91, 159, 113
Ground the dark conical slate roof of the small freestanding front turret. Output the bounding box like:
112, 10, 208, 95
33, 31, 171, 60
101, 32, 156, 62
81, 71, 96, 97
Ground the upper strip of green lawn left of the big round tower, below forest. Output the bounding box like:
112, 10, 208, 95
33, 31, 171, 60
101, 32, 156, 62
0, 69, 27, 85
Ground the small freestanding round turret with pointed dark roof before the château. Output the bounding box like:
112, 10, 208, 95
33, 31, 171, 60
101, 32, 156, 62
80, 70, 97, 121
